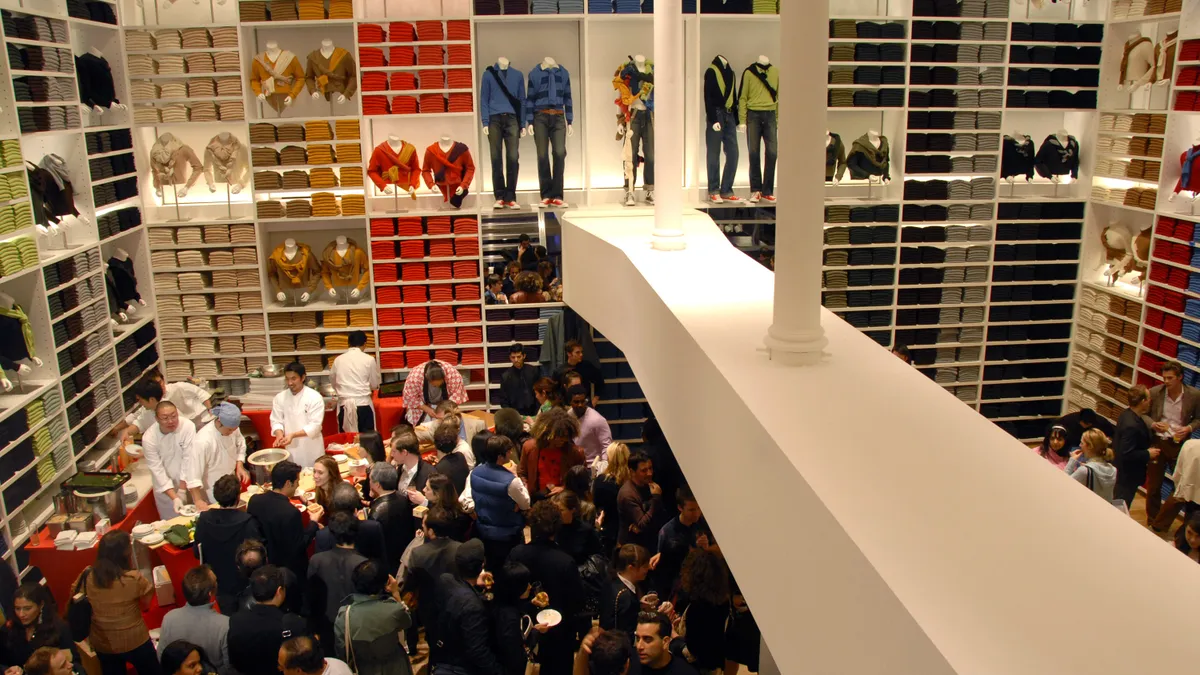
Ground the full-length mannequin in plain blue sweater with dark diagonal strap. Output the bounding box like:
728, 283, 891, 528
479, 56, 526, 209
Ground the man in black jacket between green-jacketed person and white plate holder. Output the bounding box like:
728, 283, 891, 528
430, 539, 499, 675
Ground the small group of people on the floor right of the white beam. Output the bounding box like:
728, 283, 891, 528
1036, 362, 1200, 562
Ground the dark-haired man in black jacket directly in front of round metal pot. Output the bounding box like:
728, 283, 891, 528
246, 460, 317, 593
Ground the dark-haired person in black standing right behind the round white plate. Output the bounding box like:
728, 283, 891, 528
509, 500, 590, 675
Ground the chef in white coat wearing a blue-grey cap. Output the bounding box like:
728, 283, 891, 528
184, 404, 250, 508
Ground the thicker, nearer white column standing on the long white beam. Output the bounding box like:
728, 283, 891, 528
763, 0, 829, 365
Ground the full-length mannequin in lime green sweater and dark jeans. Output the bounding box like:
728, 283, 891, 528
738, 55, 779, 203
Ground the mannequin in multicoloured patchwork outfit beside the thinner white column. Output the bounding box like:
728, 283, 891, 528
612, 54, 654, 207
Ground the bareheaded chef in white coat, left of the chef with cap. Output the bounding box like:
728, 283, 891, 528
142, 401, 196, 520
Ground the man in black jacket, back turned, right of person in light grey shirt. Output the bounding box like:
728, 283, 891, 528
228, 562, 305, 675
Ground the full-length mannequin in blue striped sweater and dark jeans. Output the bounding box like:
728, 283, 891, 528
522, 56, 575, 208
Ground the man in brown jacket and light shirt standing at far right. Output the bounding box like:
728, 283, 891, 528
1146, 362, 1200, 525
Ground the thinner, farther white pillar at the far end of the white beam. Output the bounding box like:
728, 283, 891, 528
654, 0, 691, 251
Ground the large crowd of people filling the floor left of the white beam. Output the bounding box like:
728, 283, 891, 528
0, 342, 753, 675
